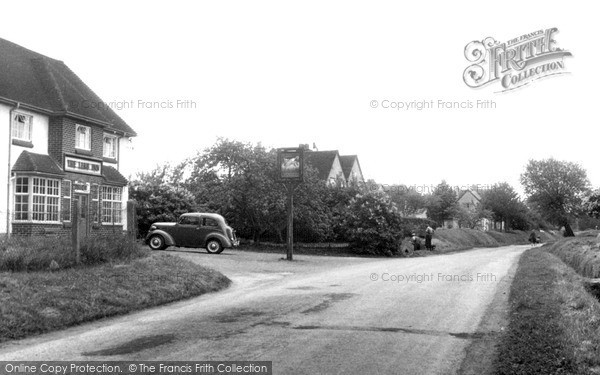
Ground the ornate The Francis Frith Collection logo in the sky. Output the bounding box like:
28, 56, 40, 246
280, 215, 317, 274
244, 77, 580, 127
463, 27, 571, 92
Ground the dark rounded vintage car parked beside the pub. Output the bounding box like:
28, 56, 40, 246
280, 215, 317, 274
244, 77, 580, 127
146, 212, 239, 254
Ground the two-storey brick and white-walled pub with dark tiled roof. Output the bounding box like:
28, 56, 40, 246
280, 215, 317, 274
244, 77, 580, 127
0, 39, 136, 235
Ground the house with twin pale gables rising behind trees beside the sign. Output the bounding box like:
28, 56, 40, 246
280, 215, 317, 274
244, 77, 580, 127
304, 149, 365, 186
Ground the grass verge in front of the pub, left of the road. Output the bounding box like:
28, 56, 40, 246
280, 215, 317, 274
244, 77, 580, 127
0, 254, 231, 342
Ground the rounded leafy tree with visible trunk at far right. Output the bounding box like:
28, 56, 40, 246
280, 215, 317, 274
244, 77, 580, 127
521, 158, 589, 237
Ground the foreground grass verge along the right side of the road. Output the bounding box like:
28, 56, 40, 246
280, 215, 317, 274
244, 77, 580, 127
494, 246, 600, 374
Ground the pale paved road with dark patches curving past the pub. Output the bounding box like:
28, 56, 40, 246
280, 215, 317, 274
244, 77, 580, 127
0, 246, 526, 374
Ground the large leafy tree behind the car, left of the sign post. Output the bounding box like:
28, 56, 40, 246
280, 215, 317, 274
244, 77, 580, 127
185, 138, 285, 241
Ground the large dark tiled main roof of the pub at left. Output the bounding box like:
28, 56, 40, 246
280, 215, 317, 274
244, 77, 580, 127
0, 38, 136, 136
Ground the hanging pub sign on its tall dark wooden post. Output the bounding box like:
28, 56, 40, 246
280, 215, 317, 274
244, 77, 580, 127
277, 147, 304, 260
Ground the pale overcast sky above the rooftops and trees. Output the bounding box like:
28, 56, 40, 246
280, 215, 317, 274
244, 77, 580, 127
0, 1, 600, 194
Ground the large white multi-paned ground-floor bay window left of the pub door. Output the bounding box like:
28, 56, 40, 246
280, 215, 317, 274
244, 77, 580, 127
13, 176, 62, 224
